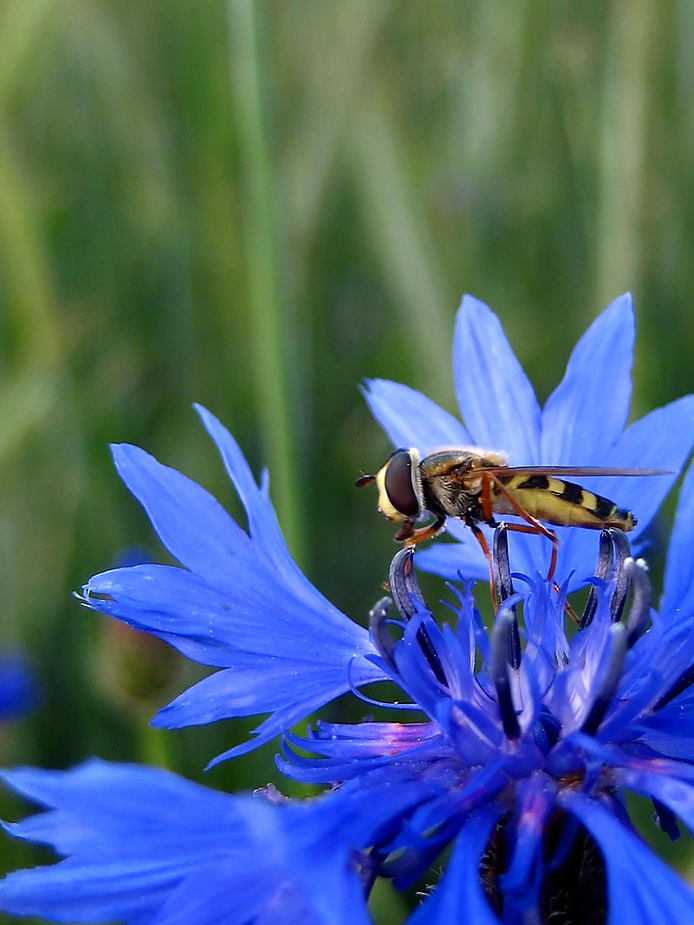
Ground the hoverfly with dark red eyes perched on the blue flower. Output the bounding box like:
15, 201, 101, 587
355, 447, 667, 585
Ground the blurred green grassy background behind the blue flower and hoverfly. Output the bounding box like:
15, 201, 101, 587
0, 0, 694, 920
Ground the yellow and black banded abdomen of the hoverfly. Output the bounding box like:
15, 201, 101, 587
493, 474, 636, 532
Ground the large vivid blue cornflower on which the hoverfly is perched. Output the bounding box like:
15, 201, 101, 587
0, 301, 694, 925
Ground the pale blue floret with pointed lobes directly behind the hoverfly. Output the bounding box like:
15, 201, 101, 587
365, 294, 694, 588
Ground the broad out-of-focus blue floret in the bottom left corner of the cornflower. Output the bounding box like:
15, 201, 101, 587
0, 760, 376, 925
